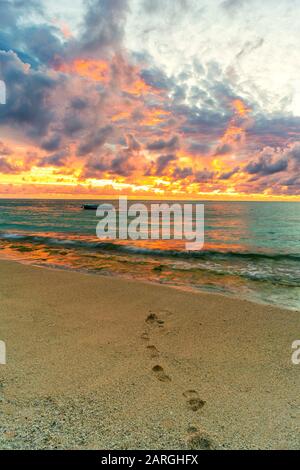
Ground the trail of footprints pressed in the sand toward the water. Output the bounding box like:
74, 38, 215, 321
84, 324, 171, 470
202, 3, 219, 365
141, 310, 214, 449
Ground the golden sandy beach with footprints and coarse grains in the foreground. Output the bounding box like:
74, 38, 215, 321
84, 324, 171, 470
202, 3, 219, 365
0, 260, 300, 449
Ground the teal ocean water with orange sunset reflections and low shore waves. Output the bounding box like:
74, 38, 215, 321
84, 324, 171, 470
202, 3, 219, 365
0, 199, 300, 310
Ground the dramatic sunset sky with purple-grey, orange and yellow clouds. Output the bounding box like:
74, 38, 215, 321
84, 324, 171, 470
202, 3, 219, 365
0, 0, 300, 200
